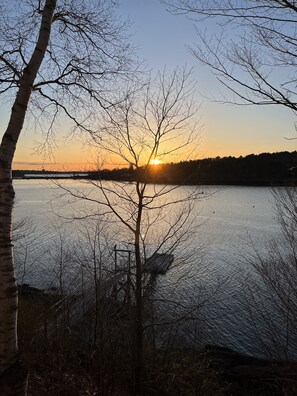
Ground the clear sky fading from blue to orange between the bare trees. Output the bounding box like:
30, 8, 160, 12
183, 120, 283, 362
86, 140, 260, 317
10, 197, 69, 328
0, 0, 296, 170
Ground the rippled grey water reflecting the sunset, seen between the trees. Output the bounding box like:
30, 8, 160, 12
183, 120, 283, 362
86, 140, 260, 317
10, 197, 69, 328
14, 180, 295, 356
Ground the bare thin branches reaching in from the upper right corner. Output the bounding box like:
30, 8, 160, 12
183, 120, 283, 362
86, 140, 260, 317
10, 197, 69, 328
162, 0, 297, 112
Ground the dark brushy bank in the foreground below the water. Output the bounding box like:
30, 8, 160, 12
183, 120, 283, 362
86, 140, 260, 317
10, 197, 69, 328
19, 285, 297, 396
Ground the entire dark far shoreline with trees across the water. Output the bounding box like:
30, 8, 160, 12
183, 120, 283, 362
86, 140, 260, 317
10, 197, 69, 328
13, 151, 297, 186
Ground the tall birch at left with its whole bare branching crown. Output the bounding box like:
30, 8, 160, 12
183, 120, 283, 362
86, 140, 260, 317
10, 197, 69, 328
0, 0, 129, 395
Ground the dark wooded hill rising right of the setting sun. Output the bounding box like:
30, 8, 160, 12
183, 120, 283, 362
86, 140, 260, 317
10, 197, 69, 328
142, 151, 297, 186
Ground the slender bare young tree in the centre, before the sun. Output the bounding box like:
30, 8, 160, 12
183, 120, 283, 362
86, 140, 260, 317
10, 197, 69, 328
56, 69, 201, 394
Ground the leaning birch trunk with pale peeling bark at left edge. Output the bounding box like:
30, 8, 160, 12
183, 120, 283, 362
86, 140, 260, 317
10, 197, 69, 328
0, 0, 56, 396
